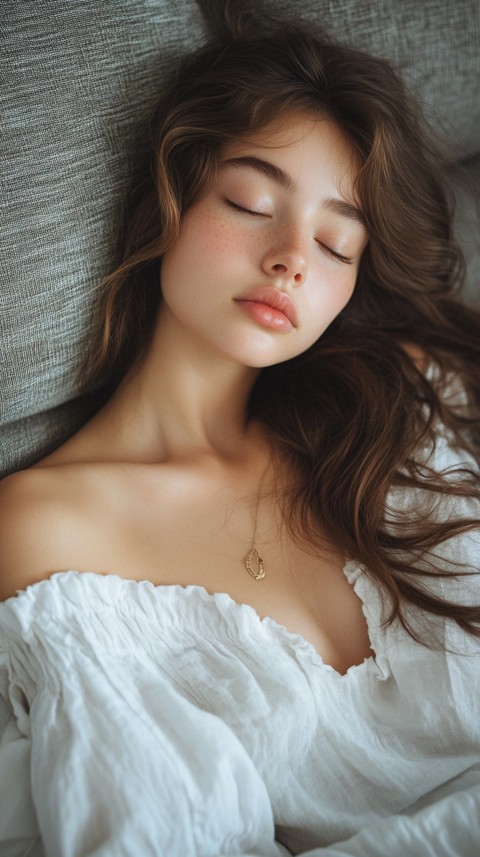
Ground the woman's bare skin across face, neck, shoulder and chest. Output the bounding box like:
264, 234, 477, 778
0, 114, 372, 673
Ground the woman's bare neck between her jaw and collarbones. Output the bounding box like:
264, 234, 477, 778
98, 306, 259, 460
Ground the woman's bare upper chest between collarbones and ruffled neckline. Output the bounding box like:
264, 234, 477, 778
80, 468, 372, 673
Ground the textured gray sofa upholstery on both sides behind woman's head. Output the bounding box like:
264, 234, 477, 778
0, 0, 480, 473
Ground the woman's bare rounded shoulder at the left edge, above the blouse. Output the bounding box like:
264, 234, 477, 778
0, 467, 99, 601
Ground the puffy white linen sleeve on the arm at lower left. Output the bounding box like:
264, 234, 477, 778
0, 612, 289, 857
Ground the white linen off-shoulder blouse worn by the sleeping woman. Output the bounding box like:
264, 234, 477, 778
0, 435, 480, 857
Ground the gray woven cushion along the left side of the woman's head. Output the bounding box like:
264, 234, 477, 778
0, 0, 205, 472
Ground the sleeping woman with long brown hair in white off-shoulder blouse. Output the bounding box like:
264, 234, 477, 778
0, 15, 480, 857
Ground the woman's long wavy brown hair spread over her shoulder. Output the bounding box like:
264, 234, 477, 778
79, 16, 480, 635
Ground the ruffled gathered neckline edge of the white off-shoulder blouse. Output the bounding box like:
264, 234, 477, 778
0, 560, 390, 680
